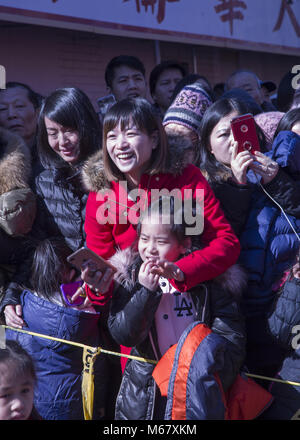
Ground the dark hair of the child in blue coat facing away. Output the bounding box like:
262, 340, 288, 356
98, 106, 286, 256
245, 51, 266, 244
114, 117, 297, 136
30, 237, 72, 301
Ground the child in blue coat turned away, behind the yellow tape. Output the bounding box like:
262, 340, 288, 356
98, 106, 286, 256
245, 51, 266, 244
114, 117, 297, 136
6, 237, 119, 420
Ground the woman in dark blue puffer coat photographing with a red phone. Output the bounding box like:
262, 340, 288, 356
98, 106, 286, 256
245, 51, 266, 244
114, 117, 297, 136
200, 98, 300, 382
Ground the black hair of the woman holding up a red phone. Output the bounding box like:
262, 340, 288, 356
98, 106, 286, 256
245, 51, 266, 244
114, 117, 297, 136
200, 97, 266, 181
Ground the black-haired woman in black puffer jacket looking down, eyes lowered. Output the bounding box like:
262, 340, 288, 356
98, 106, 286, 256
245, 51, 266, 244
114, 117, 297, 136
1, 88, 101, 327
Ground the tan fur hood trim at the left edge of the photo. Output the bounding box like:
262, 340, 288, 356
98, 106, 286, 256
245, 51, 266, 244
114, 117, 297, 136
0, 128, 31, 195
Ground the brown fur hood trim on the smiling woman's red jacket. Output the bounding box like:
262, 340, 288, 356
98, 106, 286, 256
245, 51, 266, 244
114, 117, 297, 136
81, 135, 193, 192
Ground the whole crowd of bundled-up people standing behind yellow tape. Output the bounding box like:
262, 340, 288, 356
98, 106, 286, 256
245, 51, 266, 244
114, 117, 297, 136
0, 55, 300, 420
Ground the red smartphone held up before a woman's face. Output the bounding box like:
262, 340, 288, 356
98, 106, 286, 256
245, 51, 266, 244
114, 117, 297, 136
230, 113, 260, 154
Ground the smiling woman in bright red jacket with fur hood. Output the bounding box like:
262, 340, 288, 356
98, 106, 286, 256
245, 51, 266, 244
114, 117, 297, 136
78, 98, 240, 305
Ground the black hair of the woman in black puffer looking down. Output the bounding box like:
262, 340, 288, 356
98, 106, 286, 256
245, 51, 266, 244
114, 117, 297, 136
37, 87, 101, 168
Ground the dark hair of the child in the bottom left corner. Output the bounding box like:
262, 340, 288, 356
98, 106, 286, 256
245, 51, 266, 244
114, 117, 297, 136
0, 339, 36, 382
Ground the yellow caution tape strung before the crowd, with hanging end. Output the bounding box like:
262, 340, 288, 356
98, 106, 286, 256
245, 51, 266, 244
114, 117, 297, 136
0, 324, 300, 420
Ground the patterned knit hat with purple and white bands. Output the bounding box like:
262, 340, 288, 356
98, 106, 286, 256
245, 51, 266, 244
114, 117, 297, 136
163, 82, 212, 135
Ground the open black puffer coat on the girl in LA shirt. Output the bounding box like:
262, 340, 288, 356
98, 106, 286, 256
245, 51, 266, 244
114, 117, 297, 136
108, 248, 245, 420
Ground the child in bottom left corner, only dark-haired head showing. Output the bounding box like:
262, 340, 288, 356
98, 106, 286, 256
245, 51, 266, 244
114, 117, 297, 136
0, 340, 40, 420
